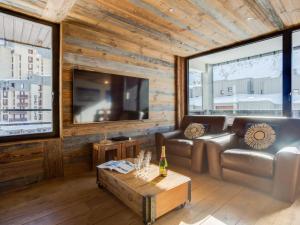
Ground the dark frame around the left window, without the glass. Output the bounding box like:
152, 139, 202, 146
0, 7, 60, 143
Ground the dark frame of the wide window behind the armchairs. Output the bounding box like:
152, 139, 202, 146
185, 25, 300, 117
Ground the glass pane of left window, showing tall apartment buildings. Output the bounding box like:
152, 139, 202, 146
0, 13, 53, 137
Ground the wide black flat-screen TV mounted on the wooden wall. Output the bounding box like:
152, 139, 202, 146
73, 69, 149, 124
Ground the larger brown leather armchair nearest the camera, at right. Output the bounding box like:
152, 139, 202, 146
206, 117, 300, 202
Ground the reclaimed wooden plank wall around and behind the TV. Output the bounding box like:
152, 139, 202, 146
62, 22, 175, 175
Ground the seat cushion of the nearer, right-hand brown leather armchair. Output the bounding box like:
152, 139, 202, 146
221, 149, 275, 177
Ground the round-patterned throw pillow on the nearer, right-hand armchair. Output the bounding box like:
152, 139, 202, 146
245, 123, 276, 150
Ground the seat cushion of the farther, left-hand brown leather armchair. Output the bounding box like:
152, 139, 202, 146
165, 139, 193, 158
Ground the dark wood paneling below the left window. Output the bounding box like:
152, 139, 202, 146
0, 139, 63, 192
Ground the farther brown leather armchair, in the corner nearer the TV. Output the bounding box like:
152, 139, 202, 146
156, 116, 228, 172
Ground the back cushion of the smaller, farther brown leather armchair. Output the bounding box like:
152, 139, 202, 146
181, 116, 226, 133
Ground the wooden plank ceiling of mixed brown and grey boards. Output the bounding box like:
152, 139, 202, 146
0, 0, 300, 56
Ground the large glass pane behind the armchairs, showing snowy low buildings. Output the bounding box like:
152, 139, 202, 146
188, 36, 284, 121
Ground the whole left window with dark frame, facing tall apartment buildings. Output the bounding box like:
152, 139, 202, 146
0, 9, 59, 141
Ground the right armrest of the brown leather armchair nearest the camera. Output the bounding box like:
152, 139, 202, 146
273, 147, 300, 202
